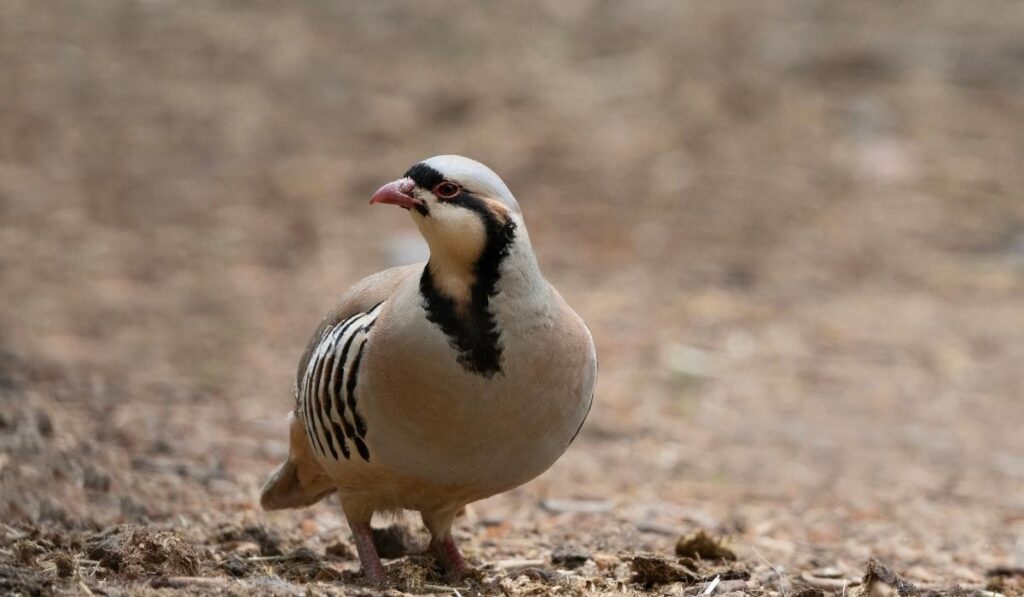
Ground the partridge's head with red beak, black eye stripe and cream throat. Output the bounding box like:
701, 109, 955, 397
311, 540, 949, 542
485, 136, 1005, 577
370, 156, 522, 282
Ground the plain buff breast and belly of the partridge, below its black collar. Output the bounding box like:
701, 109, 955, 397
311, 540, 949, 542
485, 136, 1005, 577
365, 294, 595, 493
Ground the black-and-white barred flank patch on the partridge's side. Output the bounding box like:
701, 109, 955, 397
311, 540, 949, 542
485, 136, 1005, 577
299, 303, 383, 462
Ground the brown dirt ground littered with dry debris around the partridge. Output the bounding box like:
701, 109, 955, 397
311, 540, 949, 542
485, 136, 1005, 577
0, 0, 1024, 597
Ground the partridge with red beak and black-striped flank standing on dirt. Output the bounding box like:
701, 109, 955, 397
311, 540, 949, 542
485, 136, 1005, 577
260, 156, 597, 584
